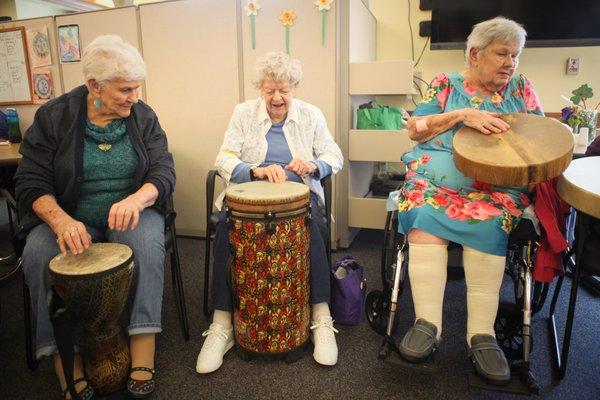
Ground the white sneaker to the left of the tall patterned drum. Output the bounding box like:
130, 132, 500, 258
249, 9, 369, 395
196, 322, 234, 374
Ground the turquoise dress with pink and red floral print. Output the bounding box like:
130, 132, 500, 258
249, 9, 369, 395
390, 73, 543, 256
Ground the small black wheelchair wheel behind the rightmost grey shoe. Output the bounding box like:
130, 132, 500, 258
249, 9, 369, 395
494, 301, 533, 360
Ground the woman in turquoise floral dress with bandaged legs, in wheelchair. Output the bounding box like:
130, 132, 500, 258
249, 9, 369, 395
391, 17, 542, 384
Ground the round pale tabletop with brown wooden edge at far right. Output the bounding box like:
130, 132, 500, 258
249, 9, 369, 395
557, 156, 600, 218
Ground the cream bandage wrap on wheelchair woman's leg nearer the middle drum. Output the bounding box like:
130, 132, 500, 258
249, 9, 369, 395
408, 243, 448, 339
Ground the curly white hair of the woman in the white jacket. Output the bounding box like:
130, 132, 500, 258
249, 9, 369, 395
252, 51, 302, 90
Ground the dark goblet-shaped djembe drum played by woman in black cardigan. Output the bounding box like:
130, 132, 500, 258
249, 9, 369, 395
50, 243, 134, 394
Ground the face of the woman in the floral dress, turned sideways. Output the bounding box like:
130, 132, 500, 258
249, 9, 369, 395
469, 42, 521, 92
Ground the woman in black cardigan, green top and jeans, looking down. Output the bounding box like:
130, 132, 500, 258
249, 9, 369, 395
15, 35, 175, 399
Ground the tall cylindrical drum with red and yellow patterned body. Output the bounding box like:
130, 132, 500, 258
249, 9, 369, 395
225, 181, 310, 361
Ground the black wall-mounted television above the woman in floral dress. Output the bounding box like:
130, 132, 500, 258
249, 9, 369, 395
431, 0, 600, 50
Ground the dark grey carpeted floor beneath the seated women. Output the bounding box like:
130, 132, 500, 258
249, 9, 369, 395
0, 223, 600, 400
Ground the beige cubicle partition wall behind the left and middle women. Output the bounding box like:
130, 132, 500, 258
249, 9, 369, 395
0, 0, 384, 247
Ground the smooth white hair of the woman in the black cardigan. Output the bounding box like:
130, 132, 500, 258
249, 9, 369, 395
82, 35, 146, 85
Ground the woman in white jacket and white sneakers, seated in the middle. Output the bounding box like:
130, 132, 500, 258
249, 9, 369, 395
196, 52, 343, 374
